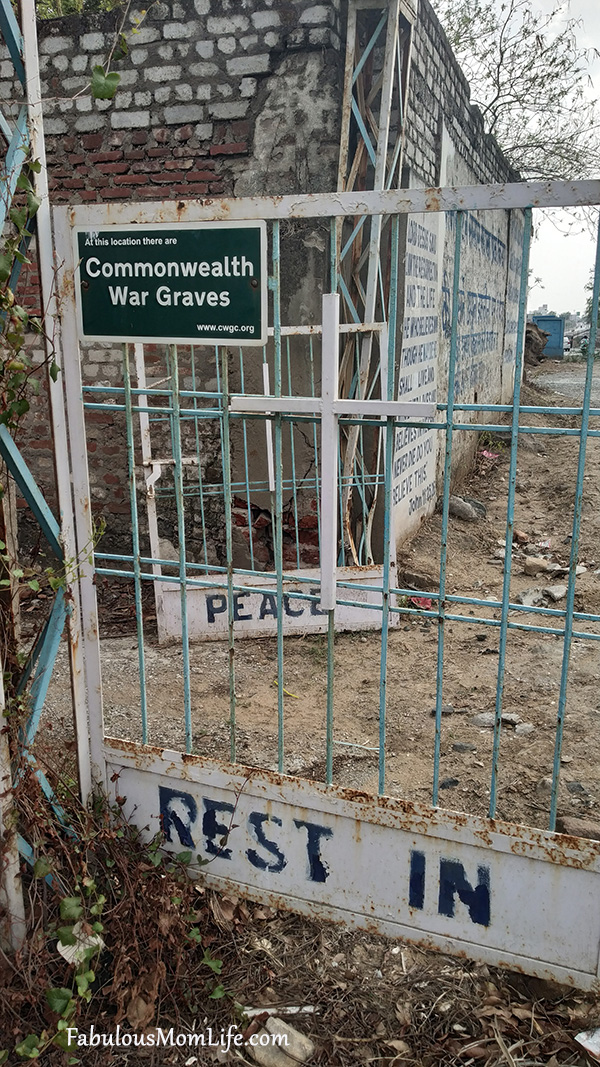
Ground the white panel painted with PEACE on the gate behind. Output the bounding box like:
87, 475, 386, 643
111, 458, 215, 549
157, 567, 398, 642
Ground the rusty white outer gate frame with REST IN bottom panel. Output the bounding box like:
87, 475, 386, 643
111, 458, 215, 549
54, 181, 600, 989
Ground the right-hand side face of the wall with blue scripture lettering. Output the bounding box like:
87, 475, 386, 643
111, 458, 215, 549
393, 6, 523, 541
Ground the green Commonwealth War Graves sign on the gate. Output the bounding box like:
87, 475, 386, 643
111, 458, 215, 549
75, 222, 267, 345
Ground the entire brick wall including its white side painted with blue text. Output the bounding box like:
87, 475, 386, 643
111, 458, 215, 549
0, 0, 519, 563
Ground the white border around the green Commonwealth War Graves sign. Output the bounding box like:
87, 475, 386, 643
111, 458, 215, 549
73, 219, 268, 348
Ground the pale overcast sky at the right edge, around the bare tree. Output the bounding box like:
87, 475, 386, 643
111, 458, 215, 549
528, 0, 600, 314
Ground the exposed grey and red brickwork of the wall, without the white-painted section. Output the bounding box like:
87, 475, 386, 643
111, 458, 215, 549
0, 0, 515, 561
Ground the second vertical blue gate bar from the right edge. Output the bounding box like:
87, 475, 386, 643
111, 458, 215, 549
489, 208, 532, 818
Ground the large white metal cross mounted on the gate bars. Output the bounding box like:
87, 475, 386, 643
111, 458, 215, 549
230, 292, 436, 611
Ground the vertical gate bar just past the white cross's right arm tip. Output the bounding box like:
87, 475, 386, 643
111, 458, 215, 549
432, 211, 463, 807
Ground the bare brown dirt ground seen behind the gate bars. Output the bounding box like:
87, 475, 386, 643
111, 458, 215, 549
42, 362, 600, 827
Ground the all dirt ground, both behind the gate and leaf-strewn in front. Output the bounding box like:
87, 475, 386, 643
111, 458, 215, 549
25, 363, 600, 1067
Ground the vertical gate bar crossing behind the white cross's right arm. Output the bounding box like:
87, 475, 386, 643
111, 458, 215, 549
378, 214, 399, 795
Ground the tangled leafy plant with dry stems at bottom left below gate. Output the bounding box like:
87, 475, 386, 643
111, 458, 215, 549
0, 751, 228, 1065
